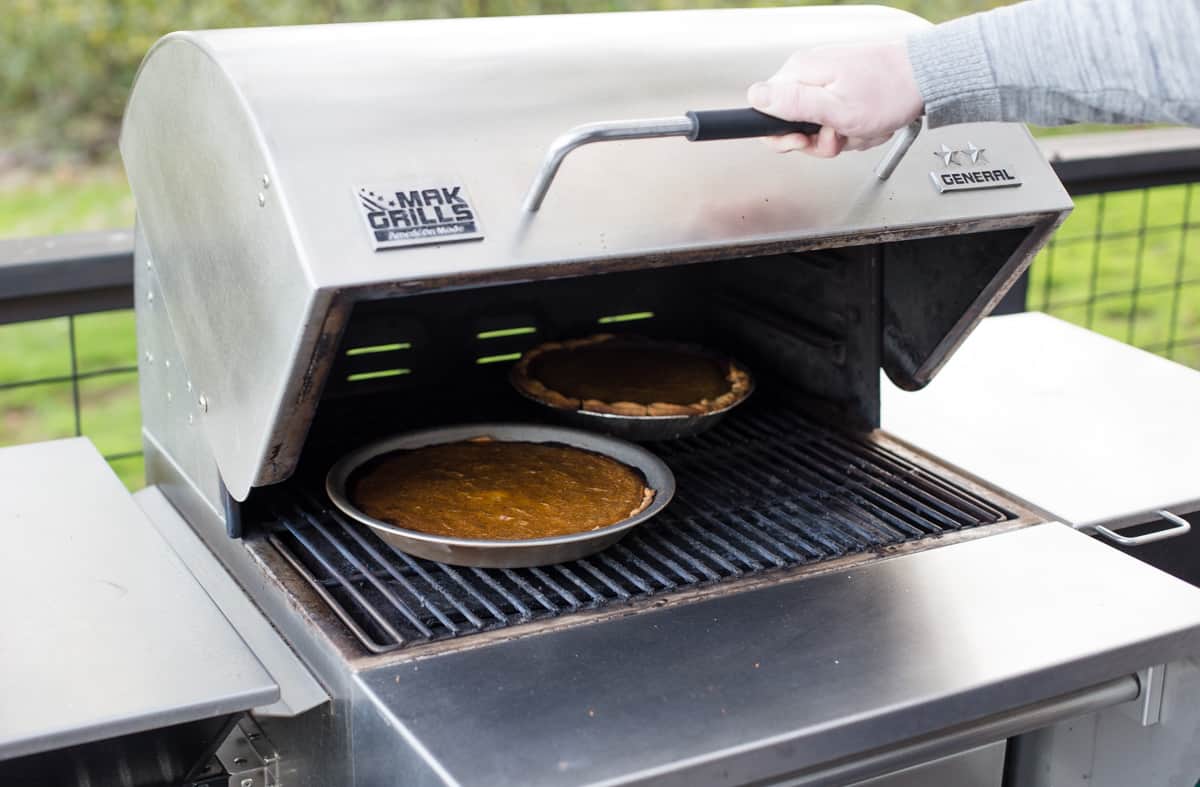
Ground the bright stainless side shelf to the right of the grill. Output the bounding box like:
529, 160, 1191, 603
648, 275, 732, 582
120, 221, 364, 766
882, 313, 1200, 531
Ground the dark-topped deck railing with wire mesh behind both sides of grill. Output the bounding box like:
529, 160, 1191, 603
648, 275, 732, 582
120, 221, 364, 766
0, 130, 1200, 483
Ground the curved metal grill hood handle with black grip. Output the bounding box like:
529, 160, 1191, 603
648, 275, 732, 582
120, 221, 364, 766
523, 108, 922, 214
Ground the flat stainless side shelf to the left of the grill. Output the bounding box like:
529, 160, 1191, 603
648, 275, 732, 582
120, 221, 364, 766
0, 438, 280, 759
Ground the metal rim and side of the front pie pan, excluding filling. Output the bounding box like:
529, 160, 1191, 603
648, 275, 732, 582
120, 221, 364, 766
325, 423, 676, 569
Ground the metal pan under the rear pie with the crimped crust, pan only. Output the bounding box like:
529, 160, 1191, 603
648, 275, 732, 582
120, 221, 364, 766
509, 340, 755, 443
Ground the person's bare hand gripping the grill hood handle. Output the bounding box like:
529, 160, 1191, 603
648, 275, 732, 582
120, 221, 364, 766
746, 41, 925, 158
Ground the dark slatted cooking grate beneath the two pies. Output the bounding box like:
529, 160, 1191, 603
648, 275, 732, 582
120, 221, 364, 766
269, 397, 1015, 653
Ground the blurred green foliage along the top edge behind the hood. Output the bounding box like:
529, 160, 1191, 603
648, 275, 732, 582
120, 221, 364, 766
0, 0, 1004, 160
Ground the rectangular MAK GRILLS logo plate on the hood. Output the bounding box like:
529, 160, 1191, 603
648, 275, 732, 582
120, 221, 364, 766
354, 179, 484, 251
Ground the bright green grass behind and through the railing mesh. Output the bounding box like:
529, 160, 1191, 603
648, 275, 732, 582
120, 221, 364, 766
0, 158, 1200, 488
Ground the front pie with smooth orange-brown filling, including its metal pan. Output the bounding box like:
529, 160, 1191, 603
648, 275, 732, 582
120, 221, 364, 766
326, 423, 674, 569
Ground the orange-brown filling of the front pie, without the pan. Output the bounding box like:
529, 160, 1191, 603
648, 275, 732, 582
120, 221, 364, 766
350, 438, 654, 540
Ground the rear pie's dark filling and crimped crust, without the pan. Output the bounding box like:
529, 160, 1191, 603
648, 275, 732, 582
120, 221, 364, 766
512, 334, 750, 415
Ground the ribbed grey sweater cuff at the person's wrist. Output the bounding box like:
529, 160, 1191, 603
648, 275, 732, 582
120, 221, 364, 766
908, 17, 1001, 128
